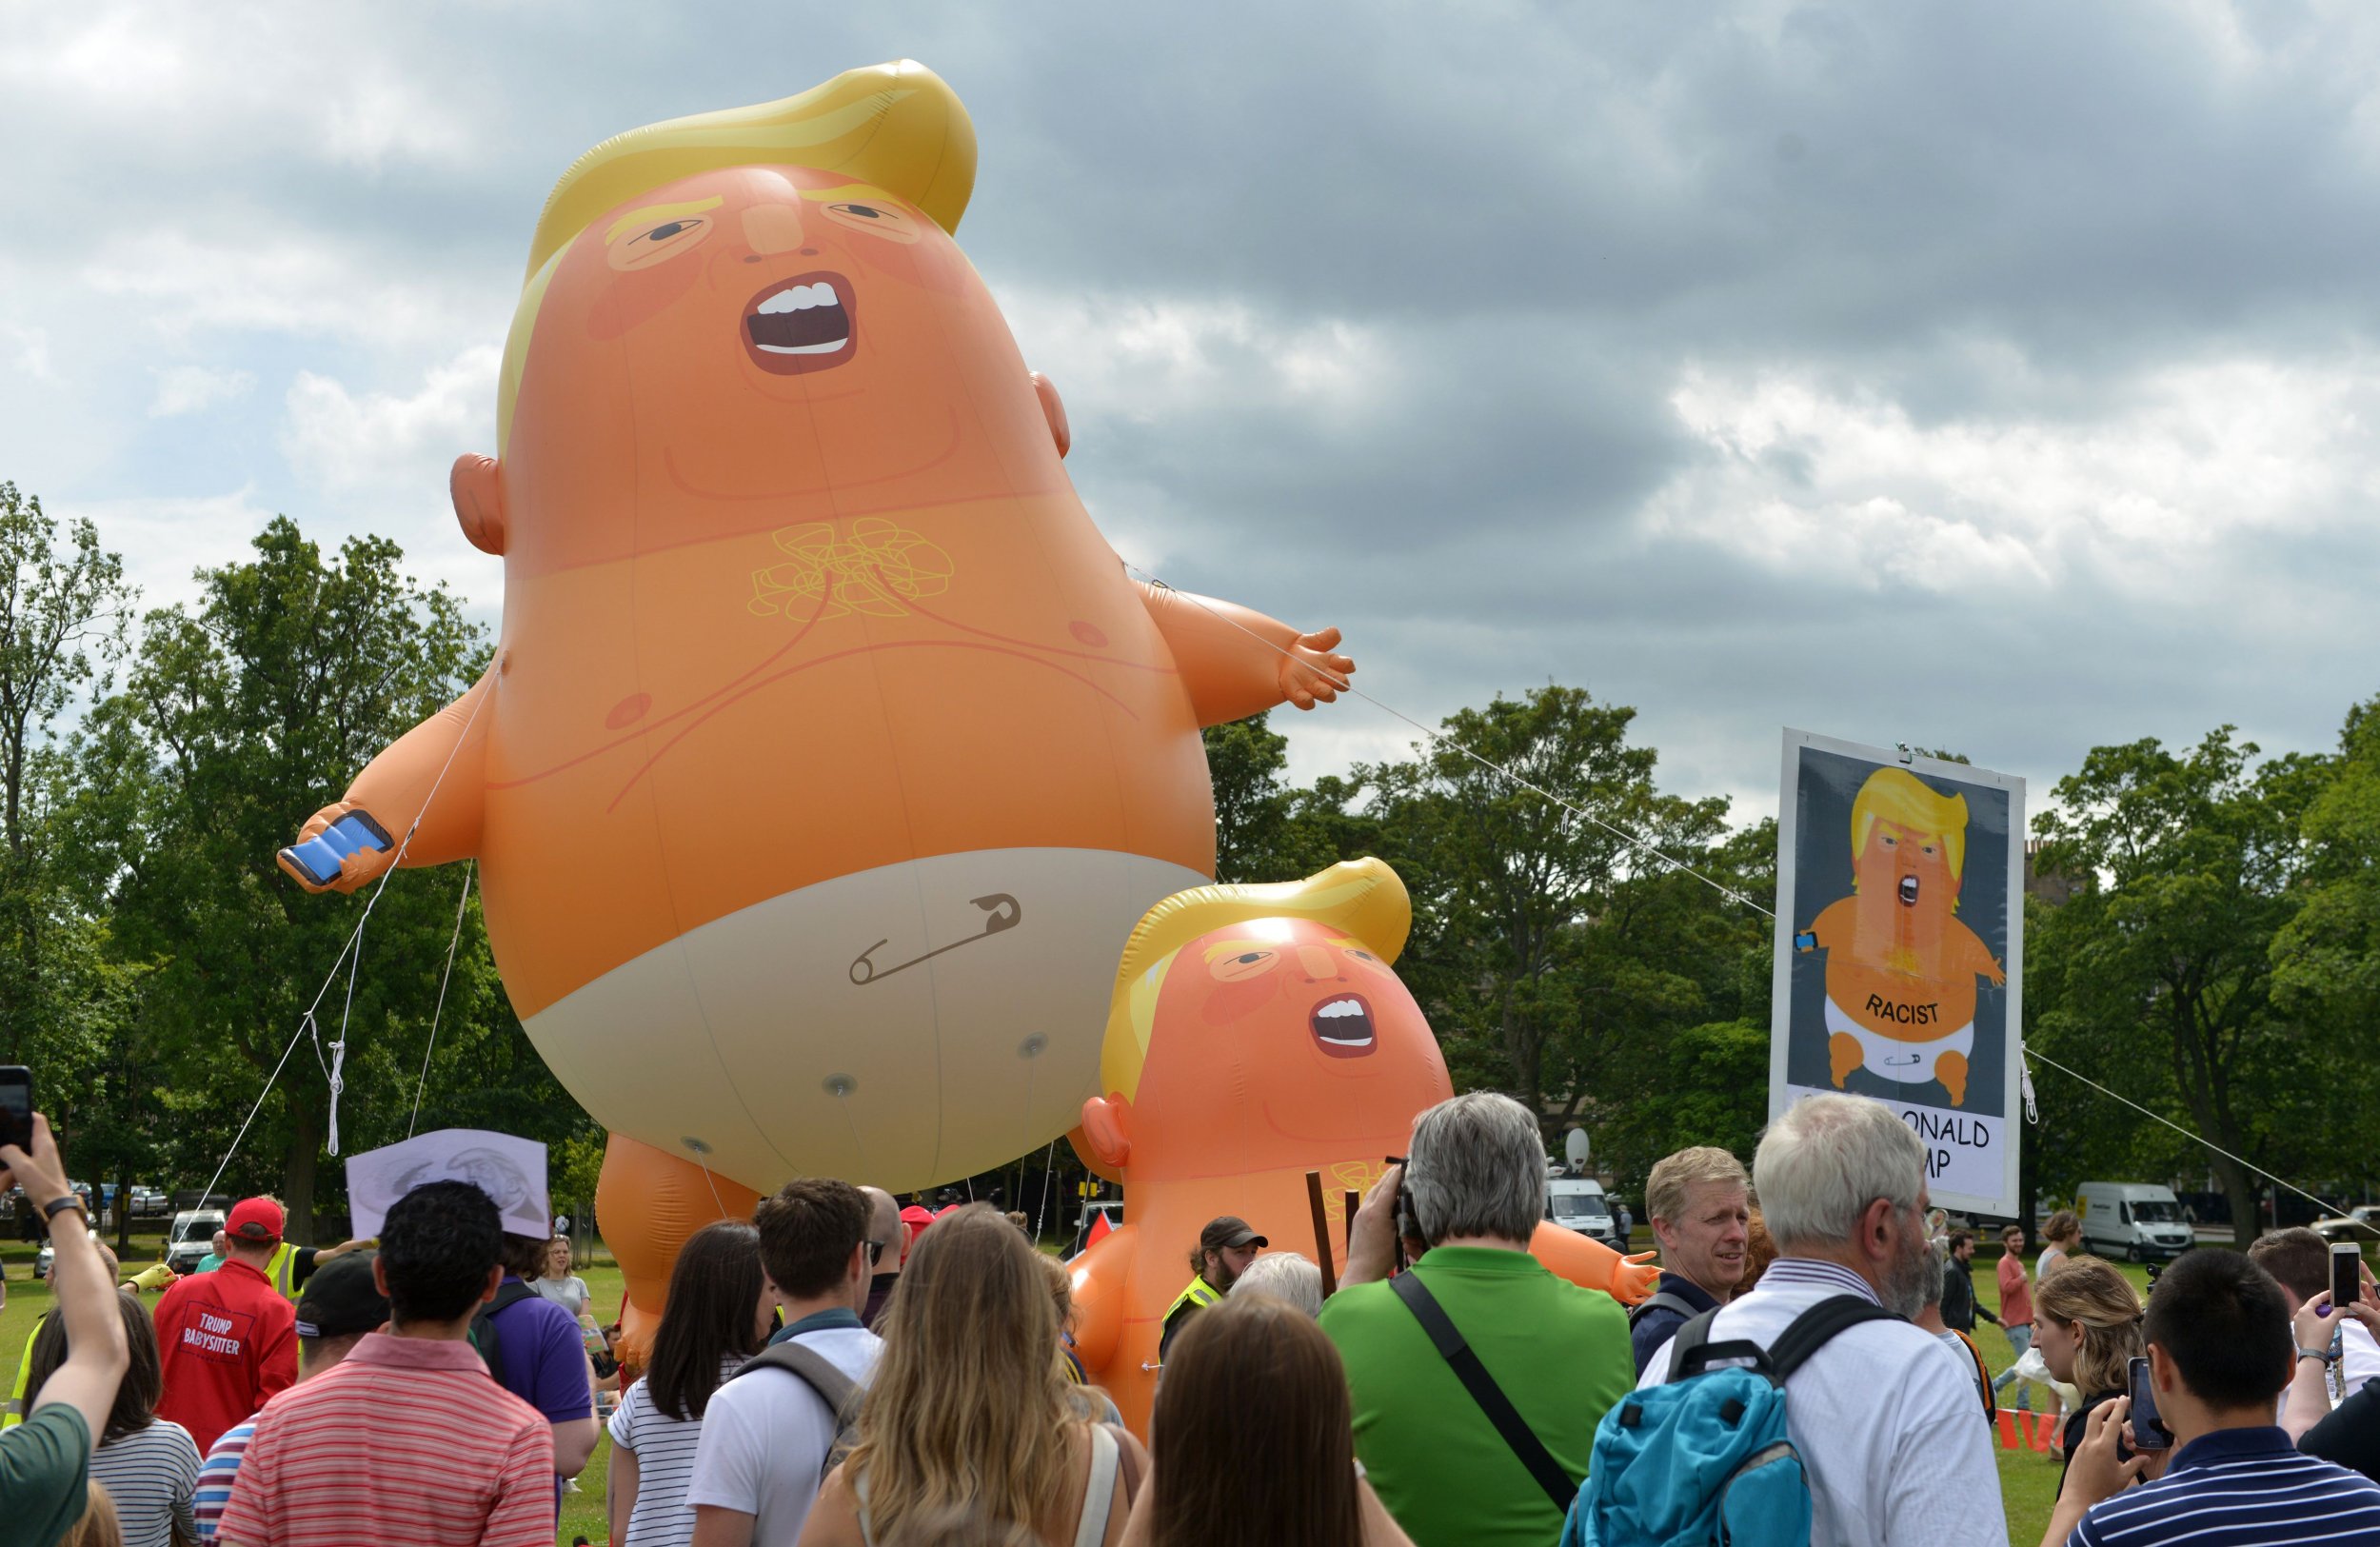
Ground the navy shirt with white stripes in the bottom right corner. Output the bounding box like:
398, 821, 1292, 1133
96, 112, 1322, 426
2066, 1426, 2380, 1547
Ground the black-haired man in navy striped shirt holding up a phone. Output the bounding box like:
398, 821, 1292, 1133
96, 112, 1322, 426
2042, 1250, 2380, 1547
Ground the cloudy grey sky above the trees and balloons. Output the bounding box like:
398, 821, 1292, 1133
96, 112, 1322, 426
0, 0, 2380, 819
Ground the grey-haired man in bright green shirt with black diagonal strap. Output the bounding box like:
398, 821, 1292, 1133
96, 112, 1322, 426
1321, 1095, 1631, 1547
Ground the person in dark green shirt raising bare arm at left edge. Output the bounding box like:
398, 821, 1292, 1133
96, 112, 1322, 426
0, 1114, 131, 1547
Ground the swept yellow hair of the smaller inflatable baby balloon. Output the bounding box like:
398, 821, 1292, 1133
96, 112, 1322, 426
1100, 857, 1414, 1100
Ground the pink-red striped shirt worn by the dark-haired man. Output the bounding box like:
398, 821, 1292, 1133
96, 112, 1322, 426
219, 1333, 555, 1547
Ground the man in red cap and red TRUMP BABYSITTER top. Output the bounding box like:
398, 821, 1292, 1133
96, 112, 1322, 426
157, 1198, 298, 1455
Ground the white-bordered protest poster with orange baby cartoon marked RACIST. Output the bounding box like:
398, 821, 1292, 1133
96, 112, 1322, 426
1769, 728, 2026, 1219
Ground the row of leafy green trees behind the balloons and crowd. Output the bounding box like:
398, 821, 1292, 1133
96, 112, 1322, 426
0, 484, 2380, 1233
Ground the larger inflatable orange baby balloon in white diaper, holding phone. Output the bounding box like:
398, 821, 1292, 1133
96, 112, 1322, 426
284, 62, 1352, 1309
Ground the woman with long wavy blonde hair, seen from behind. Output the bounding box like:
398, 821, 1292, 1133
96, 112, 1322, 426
803, 1204, 1150, 1547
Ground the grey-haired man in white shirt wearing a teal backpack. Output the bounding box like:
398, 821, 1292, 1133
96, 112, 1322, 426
1637, 1095, 2009, 1547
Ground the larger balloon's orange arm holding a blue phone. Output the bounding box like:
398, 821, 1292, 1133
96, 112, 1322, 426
281, 666, 498, 893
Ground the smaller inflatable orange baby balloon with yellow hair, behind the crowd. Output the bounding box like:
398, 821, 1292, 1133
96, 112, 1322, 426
1074, 860, 1659, 1433
